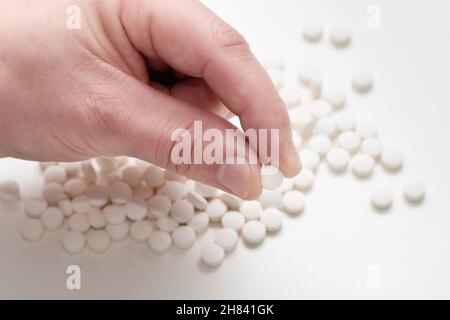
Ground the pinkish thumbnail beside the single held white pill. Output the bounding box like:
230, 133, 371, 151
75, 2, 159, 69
217, 158, 251, 198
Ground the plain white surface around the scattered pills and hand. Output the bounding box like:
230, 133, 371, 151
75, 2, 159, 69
0, 0, 450, 299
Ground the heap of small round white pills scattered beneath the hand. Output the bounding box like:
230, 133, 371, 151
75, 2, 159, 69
0, 21, 426, 267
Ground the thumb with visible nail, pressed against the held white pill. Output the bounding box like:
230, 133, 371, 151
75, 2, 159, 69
95, 77, 261, 199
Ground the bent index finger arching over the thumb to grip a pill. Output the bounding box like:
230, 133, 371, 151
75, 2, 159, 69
122, 0, 301, 177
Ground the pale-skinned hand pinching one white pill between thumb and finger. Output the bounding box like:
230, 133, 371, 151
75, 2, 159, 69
0, 0, 301, 199
